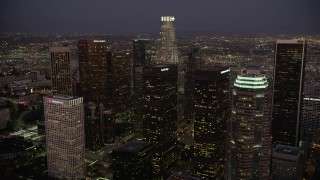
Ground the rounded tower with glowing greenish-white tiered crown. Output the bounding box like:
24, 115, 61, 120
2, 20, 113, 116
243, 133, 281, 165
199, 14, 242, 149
225, 69, 272, 179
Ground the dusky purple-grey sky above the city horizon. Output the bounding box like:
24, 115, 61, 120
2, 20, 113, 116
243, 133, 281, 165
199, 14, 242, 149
0, 0, 320, 34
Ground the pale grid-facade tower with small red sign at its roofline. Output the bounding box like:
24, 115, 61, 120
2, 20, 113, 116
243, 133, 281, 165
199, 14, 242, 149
43, 95, 86, 179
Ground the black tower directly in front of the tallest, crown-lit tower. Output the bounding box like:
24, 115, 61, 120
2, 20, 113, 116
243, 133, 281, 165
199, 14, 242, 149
142, 64, 178, 176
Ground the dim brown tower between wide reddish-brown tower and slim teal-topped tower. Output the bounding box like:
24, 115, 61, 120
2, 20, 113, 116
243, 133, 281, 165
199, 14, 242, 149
107, 52, 132, 122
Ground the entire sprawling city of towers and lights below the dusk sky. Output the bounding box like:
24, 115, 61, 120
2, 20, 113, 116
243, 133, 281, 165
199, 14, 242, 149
0, 9, 320, 179
